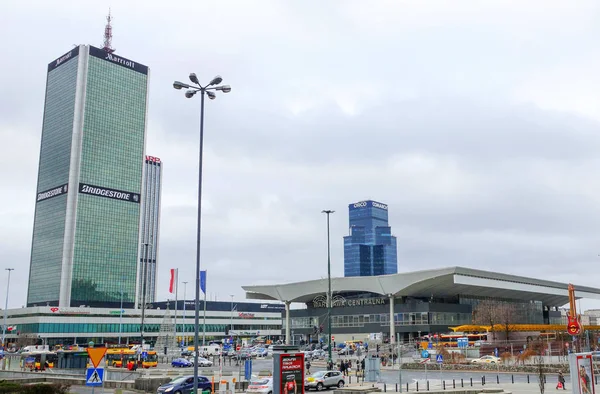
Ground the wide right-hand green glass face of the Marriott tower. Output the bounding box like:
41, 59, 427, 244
71, 56, 147, 305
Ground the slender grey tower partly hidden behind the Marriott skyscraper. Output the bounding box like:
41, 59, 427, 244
138, 156, 163, 305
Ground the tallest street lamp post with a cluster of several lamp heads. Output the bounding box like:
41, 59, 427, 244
173, 73, 231, 394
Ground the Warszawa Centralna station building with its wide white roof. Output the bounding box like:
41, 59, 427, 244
243, 267, 600, 343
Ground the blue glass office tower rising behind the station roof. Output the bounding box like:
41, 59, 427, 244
344, 200, 398, 276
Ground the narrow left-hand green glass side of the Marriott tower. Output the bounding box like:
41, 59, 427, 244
27, 52, 78, 304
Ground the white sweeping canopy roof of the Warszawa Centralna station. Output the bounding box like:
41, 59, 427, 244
242, 267, 600, 307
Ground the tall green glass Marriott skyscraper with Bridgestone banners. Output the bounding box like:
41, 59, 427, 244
27, 45, 149, 307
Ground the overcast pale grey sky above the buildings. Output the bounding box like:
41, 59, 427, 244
0, 0, 600, 307
